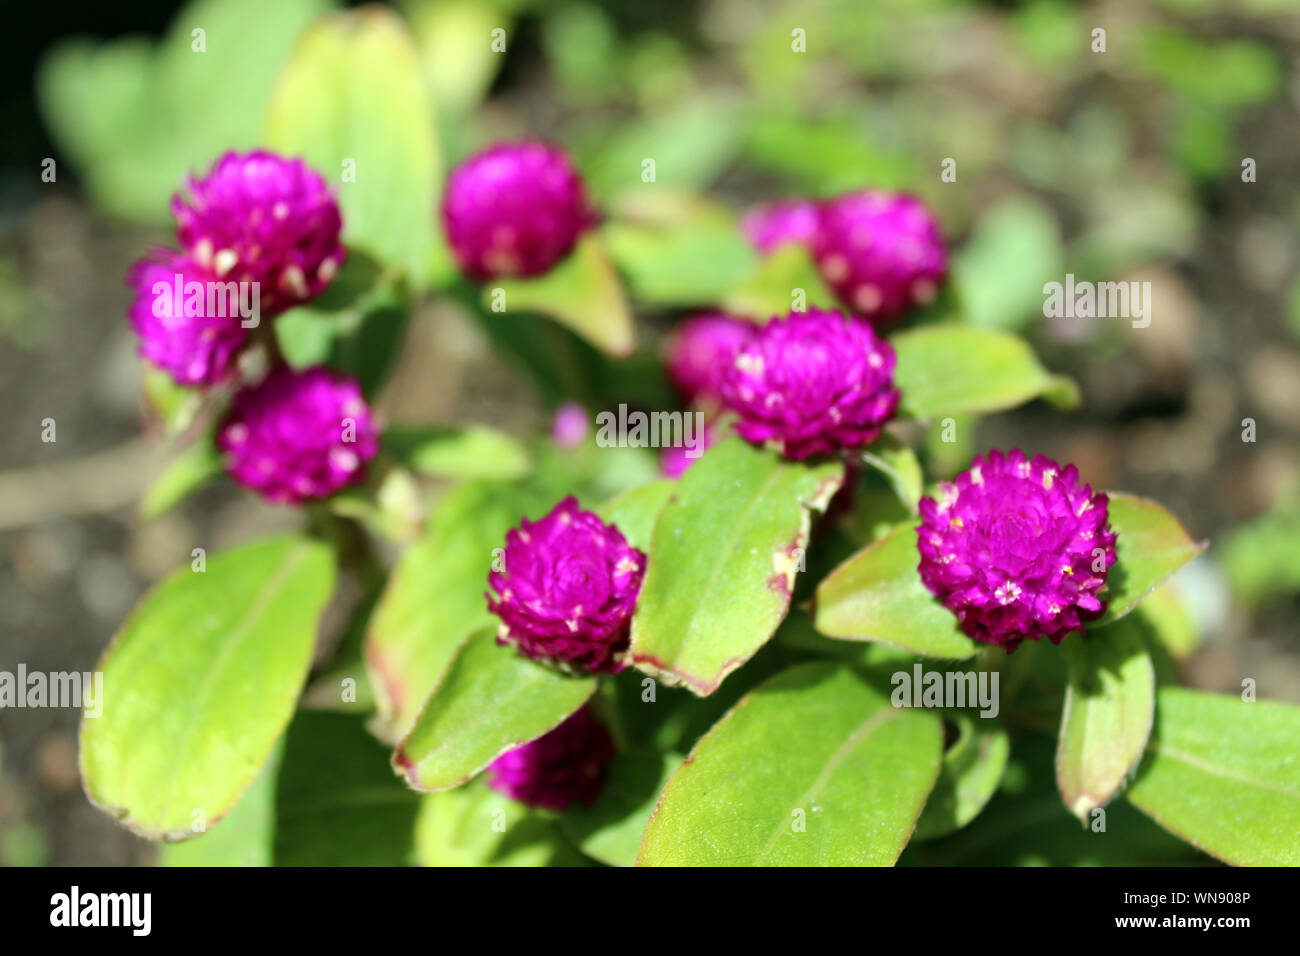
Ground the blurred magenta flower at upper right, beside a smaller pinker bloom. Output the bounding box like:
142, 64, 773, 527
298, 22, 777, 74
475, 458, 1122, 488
813, 190, 948, 323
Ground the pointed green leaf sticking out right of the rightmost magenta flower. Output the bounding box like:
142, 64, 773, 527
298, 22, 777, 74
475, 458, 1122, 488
1089, 492, 1205, 630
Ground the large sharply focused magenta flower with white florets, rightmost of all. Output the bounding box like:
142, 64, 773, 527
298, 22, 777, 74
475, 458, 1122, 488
917, 449, 1115, 653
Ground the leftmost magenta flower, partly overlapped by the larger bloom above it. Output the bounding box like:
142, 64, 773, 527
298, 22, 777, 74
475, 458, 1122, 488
126, 250, 248, 385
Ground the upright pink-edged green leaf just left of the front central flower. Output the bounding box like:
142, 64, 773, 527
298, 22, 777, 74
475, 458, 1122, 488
365, 481, 551, 741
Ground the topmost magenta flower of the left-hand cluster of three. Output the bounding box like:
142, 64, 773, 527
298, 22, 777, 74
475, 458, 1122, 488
172, 150, 347, 315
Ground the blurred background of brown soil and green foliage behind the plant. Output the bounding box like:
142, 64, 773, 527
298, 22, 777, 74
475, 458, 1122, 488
0, 0, 1300, 865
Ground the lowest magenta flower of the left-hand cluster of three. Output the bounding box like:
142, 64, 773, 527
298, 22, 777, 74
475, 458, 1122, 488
217, 367, 380, 503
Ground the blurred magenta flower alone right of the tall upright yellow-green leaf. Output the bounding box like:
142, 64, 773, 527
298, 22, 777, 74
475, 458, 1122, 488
442, 142, 595, 281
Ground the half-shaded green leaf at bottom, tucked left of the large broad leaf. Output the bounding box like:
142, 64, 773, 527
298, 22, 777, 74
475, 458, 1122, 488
560, 750, 681, 866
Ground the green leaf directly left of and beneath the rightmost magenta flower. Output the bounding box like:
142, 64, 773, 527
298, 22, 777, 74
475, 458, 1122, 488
811, 522, 976, 659
